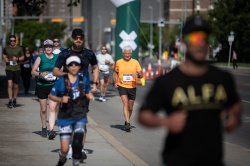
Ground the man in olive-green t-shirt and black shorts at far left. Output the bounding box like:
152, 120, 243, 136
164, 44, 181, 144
3, 35, 24, 108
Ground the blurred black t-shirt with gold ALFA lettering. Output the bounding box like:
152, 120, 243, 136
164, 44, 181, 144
140, 66, 239, 166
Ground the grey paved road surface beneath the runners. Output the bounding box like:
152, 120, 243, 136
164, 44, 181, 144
0, 60, 250, 166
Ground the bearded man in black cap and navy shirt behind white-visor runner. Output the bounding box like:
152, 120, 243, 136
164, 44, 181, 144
53, 29, 99, 159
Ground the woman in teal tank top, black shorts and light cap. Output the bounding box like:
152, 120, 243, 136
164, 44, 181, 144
32, 39, 58, 139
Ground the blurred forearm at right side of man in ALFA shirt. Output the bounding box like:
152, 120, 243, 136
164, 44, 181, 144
224, 102, 242, 132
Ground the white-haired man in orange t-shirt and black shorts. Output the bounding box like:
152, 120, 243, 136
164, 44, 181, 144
115, 46, 142, 131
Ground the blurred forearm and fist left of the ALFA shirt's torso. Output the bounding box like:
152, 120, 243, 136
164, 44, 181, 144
138, 110, 187, 134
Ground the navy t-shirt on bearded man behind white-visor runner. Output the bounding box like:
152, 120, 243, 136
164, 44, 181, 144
54, 48, 97, 79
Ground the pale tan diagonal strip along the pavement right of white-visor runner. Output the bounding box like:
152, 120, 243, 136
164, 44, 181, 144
88, 116, 148, 166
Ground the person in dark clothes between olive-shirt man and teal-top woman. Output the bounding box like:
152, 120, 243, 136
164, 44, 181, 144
20, 46, 33, 95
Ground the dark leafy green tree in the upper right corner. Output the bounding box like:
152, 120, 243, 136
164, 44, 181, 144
209, 0, 250, 62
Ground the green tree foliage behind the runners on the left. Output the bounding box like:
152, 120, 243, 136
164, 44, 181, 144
11, 21, 66, 50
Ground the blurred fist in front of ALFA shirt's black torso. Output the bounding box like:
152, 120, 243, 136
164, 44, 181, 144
164, 111, 187, 134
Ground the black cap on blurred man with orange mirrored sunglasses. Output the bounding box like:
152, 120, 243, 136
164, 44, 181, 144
182, 16, 210, 35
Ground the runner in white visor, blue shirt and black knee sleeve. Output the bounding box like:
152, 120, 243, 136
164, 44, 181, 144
49, 56, 94, 166
